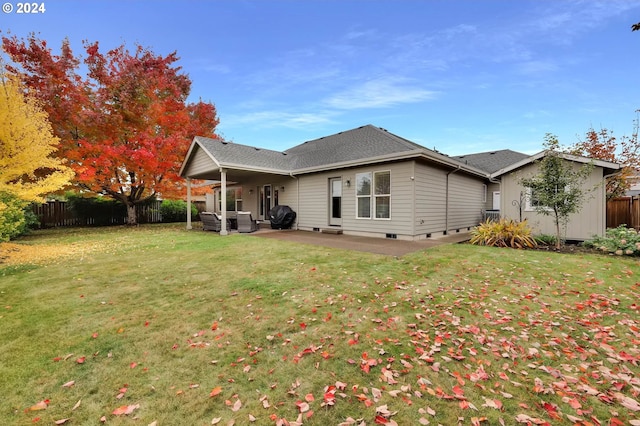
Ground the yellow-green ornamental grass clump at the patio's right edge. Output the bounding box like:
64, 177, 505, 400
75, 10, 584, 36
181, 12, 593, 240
470, 218, 538, 249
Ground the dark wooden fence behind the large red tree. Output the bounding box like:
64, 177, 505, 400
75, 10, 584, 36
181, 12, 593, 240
33, 200, 205, 228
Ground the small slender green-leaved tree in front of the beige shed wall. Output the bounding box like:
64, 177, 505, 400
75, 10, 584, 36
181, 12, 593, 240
519, 134, 593, 249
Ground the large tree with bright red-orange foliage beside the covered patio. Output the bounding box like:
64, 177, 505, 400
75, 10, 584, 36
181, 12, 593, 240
2, 35, 218, 225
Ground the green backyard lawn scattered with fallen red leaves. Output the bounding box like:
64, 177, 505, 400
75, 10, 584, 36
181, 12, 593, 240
0, 225, 640, 426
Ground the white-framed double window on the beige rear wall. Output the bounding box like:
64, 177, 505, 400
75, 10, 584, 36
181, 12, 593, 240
356, 171, 391, 219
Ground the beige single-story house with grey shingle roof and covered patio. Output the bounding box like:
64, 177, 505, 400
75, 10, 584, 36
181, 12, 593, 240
180, 125, 618, 240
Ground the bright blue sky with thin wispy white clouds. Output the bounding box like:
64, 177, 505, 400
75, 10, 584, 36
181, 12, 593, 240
0, 0, 640, 155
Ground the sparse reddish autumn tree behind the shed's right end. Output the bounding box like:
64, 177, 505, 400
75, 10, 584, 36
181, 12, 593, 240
571, 113, 640, 198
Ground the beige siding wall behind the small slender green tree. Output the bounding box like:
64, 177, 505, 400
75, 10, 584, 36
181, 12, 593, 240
501, 164, 606, 240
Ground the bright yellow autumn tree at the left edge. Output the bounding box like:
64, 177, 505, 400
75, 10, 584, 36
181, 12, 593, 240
0, 74, 74, 203
